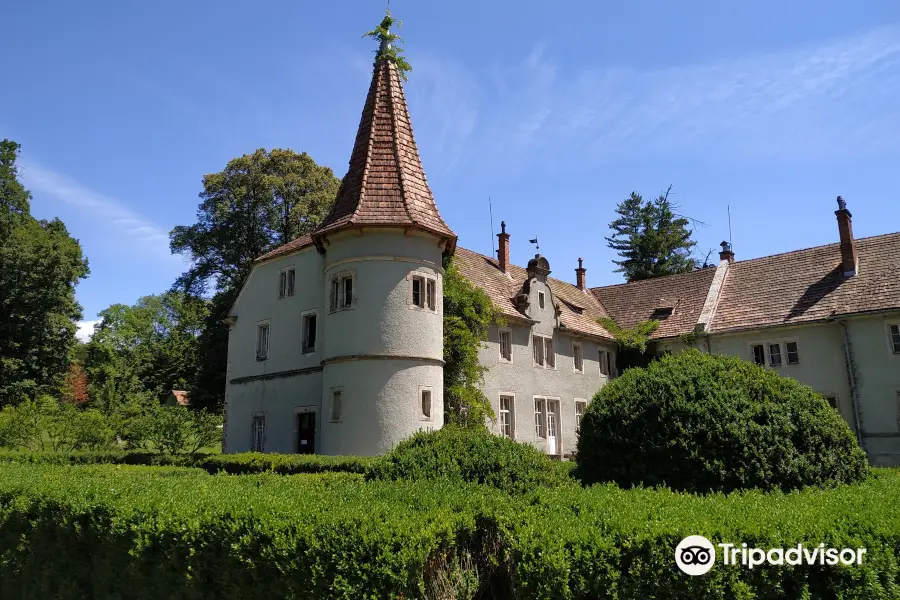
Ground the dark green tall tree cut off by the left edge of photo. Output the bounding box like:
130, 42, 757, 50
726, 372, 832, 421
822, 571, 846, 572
0, 140, 89, 405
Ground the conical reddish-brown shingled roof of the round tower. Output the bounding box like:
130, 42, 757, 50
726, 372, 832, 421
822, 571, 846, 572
313, 58, 456, 253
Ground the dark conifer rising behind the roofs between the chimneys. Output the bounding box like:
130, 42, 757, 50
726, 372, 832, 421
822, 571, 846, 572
606, 186, 697, 281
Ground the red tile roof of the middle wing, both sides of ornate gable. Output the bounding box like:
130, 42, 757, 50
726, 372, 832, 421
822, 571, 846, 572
453, 248, 612, 339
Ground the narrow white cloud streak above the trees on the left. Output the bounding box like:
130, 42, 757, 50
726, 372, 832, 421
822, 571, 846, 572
22, 160, 181, 261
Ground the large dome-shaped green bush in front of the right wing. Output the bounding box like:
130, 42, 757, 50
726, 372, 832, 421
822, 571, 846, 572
576, 350, 869, 492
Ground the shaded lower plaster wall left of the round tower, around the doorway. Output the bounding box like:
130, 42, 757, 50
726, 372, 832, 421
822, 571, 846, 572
226, 372, 327, 453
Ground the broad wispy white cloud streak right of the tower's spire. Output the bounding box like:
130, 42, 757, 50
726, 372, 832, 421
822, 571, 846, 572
414, 27, 900, 175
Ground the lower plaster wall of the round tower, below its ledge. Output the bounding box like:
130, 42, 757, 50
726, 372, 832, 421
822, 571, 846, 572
316, 360, 444, 456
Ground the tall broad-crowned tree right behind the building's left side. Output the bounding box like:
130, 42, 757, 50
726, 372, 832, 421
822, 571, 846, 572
170, 149, 340, 408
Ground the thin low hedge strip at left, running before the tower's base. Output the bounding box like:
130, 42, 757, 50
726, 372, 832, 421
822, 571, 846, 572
0, 451, 374, 475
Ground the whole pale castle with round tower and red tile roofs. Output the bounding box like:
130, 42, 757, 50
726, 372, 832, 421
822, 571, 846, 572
223, 27, 900, 464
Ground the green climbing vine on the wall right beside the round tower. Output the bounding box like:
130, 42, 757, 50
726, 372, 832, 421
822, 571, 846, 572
444, 259, 502, 427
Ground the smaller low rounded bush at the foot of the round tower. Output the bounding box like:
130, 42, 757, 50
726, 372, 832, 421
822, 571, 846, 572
367, 425, 570, 493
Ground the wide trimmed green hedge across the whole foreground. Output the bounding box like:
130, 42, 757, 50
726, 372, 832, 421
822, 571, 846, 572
0, 463, 900, 600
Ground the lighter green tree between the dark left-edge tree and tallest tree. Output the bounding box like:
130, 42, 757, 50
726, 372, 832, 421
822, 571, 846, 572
85, 292, 209, 412
